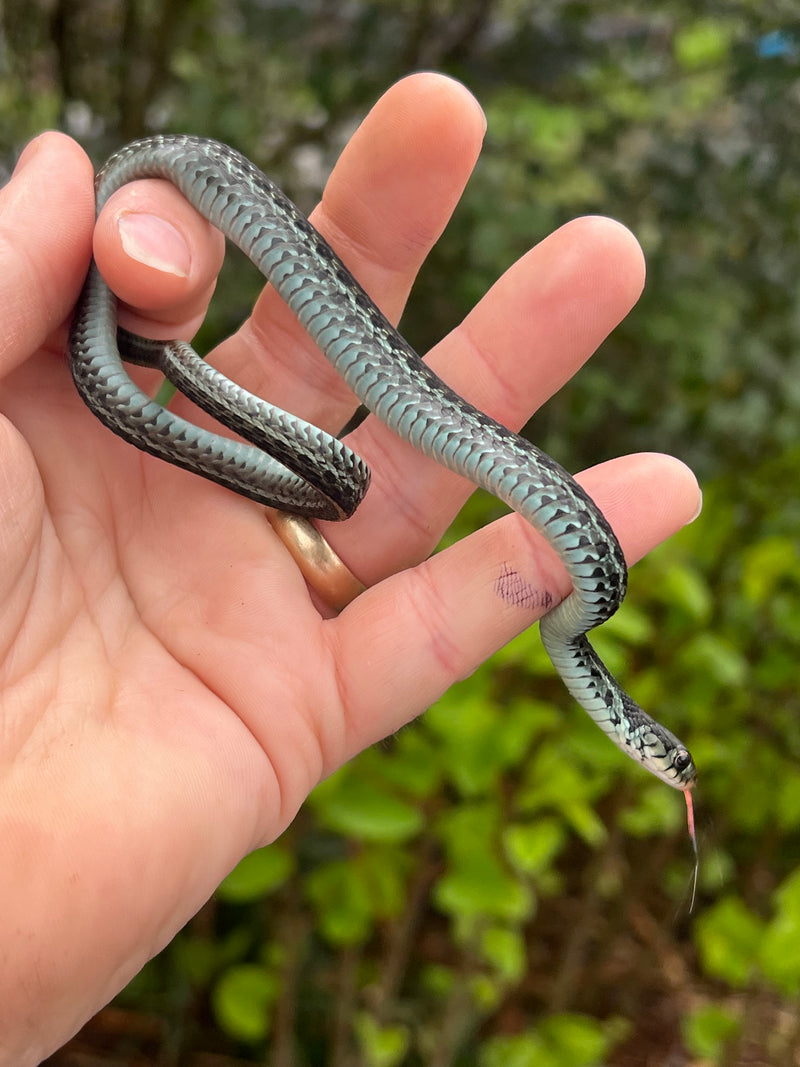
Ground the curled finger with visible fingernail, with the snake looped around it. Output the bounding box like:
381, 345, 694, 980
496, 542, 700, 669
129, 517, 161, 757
94, 179, 225, 339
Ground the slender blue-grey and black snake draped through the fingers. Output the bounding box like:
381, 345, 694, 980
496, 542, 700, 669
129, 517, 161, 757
68, 134, 697, 805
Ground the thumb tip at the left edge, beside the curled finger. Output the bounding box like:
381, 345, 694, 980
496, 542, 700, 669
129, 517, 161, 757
0, 133, 94, 375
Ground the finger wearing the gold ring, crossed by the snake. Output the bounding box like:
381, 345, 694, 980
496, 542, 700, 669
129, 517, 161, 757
325, 218, 644, 585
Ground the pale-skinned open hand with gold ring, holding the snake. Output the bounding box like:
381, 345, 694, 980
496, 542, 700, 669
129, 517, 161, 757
0, 75, 700, 1067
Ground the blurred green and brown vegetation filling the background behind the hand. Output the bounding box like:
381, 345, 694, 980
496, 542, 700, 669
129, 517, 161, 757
0, 0, 800, 1067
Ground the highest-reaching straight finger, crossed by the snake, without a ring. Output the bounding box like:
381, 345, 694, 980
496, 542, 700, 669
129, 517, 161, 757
201, 74, 485, 431
